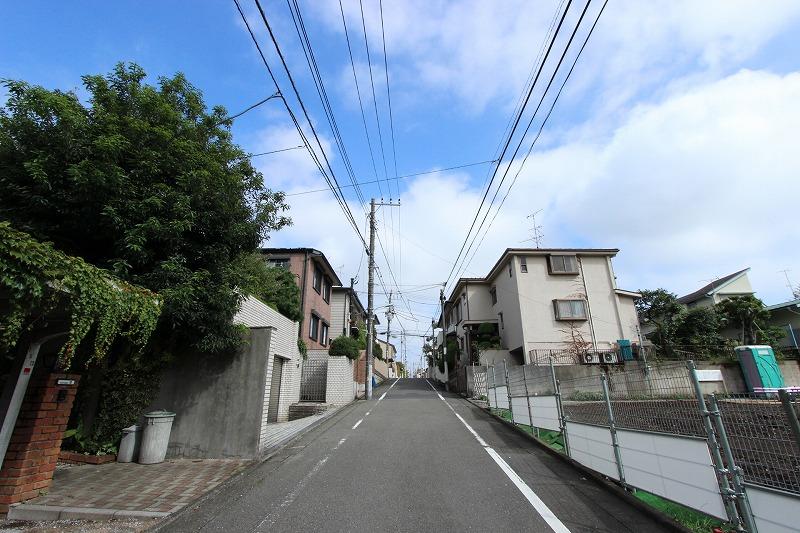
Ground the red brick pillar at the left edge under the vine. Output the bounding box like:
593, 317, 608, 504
0, 374, 80, 514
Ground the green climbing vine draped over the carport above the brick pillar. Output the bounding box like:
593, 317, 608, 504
0, 222, 161, 368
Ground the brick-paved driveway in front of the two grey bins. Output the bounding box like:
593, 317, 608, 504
18, 459, 249, 513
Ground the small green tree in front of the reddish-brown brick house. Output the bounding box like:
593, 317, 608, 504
235, 253, 303, 322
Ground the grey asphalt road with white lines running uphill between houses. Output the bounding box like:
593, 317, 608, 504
161, 379, 670, 532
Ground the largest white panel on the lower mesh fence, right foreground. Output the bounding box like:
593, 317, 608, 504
616, 429, 727, 519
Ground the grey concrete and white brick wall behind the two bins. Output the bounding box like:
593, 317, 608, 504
152, 297, 301, 458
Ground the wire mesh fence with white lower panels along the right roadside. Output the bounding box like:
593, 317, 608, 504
486, 358, 800, 531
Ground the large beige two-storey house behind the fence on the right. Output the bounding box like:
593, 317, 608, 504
444, 248, 639, 366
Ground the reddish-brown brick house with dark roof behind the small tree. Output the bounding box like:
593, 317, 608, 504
261, 248, 342, 350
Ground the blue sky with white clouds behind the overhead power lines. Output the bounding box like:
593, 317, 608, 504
0, 0, 800, 370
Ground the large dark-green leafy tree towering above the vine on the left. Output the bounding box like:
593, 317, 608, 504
0, 64, 290, 351
